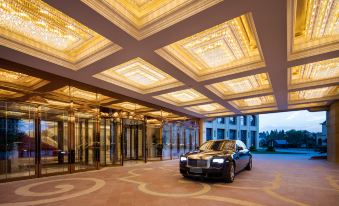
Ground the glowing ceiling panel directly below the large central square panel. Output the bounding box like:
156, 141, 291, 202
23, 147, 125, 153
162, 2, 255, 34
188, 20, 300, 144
207, 73, 272, 99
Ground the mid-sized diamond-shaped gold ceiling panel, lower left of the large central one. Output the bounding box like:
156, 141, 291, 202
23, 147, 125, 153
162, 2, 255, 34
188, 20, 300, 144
94, 58, 182, 93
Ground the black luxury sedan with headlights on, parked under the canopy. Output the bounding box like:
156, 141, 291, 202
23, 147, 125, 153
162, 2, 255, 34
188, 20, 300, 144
180, 140, 252, 183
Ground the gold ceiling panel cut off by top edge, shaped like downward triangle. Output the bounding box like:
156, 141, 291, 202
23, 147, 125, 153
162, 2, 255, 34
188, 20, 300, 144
82, 0, 222, 40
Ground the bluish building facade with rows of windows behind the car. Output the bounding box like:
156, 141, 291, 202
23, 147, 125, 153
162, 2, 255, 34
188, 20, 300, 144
203, 115, 259, 148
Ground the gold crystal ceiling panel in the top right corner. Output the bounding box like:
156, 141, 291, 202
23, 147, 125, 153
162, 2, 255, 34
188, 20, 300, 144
288, 0, 339, 60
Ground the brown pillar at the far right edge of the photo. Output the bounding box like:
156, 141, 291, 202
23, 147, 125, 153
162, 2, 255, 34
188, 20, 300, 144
326, 101, 339, 163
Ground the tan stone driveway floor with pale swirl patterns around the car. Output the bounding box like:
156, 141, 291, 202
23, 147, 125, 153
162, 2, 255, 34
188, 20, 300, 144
0, 154, 339, 206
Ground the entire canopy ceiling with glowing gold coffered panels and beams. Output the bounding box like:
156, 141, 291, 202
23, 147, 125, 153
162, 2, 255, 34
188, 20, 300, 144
0, 0, 339, 118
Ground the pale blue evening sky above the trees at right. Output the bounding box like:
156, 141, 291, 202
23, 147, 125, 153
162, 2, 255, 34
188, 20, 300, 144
259, 110, 326, 132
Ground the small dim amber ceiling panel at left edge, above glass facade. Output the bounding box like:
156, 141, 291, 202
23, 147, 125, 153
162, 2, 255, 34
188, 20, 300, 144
0, 68, 48, 90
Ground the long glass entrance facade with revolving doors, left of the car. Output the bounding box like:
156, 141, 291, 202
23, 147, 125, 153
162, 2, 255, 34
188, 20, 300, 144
0, 101, 199, 182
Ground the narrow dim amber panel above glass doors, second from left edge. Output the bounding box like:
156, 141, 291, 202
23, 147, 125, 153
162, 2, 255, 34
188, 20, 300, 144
52, 86, 115, 104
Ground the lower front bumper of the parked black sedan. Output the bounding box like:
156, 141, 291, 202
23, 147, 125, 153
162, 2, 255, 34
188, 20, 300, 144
180, 165, 227, 178
